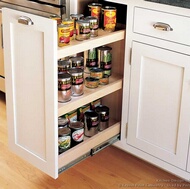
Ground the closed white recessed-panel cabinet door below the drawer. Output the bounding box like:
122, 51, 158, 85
127, 42, 190, 170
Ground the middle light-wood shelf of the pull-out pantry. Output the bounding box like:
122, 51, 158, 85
58, 75, 122, 116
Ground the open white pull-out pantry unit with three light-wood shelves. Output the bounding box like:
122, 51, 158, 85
3, 8, 125, 178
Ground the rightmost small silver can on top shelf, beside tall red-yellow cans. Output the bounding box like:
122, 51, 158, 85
85, 16, 98, 37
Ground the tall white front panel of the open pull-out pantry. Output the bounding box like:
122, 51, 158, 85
2, 8, 58, 178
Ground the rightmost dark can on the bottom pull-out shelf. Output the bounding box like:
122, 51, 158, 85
95, 105, 109, 131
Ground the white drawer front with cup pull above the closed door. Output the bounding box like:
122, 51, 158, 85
133, 7, 190, 45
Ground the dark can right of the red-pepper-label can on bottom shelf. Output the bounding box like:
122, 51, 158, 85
84, 110, 99, 137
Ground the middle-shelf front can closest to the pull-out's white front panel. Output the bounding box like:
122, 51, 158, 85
58, 73, 72, 102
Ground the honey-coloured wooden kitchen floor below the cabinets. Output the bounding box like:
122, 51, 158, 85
0, 92, 190, 189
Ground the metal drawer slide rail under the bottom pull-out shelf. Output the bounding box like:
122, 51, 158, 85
58, 134, 120, 174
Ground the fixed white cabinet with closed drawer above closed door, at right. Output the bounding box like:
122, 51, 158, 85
122, 7, 190, 180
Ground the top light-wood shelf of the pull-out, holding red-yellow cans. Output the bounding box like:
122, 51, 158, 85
57, 29, 125, 59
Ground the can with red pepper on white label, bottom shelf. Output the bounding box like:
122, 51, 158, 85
69, 121, 84, 147
